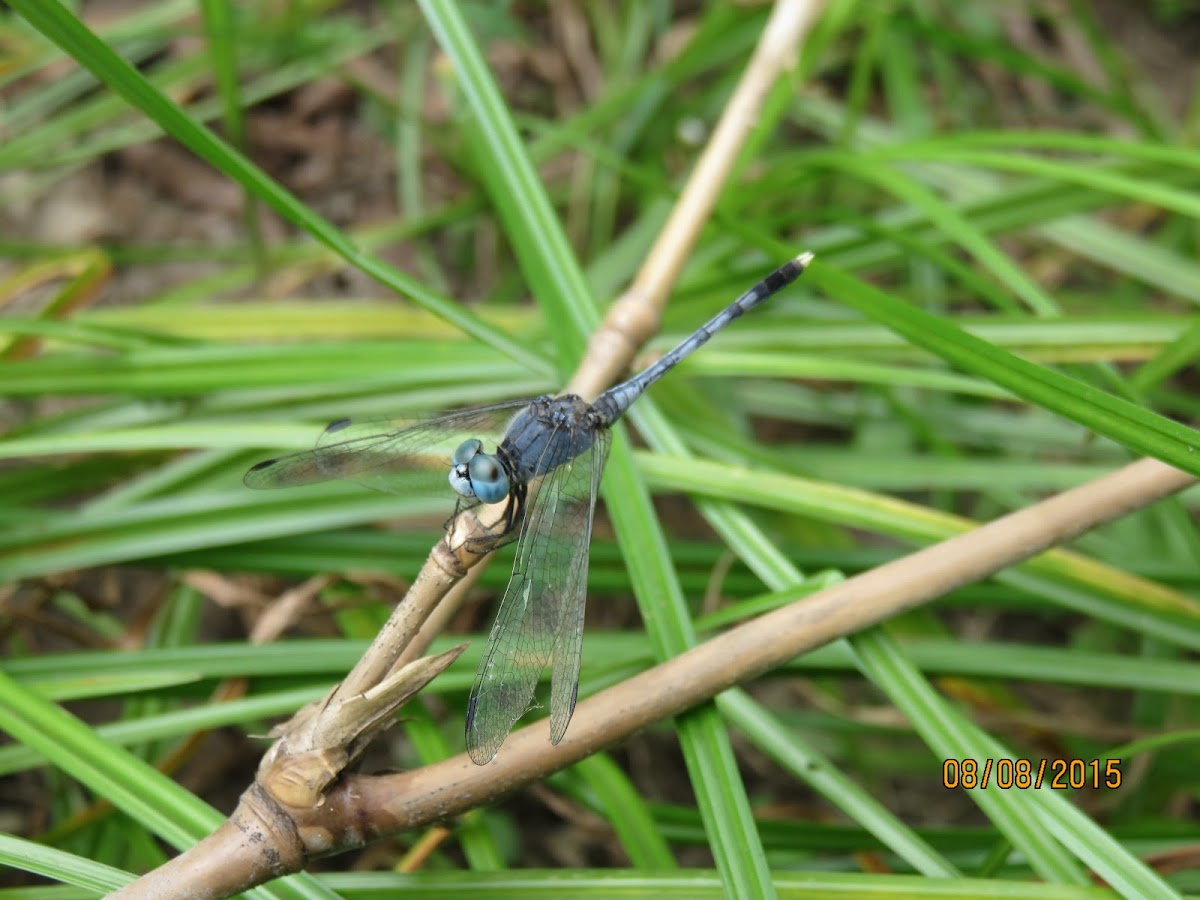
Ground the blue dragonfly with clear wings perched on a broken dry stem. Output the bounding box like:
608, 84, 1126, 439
244, 253, 812, 766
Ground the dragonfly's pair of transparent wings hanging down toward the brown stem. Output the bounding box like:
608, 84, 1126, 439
467, 430, 611, 766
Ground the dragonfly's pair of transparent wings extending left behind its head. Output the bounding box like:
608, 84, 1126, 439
242, 400, 532, 494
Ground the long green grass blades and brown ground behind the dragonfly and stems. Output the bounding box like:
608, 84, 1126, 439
0, 0, 1200, 898
